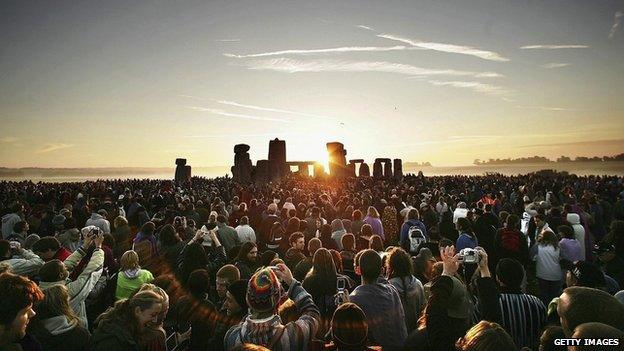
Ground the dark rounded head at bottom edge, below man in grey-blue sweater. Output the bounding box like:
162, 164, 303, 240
331, 302, 368, 350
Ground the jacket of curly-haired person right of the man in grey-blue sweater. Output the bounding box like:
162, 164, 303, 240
388, 275, 426, 333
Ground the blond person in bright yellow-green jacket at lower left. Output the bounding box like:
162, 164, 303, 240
115, 250, 154, 300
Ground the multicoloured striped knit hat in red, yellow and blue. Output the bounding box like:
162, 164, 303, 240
247, 268, 281, 312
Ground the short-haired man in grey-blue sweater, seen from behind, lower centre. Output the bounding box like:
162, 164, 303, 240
349, 249, 407, 350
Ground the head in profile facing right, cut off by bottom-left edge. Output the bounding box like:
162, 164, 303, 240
0, 273, 43, 346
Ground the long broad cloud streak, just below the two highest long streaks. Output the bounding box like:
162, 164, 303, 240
243, 57, 502, 78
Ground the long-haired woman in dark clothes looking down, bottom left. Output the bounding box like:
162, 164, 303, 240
91, 291, 164, 351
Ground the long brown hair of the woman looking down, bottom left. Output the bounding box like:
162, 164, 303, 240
95, 291, 163, 335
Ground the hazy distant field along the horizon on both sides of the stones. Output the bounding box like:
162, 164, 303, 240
0, 162, 624, 182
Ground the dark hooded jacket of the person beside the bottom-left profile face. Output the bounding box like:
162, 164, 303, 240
31, 316, 91, 351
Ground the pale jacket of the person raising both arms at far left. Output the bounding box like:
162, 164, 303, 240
39, 247, 104, 327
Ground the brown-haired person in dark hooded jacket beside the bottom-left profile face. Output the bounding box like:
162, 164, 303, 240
28, 285, 91, 351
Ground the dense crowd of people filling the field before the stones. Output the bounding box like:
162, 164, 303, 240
0, 172, 624, 351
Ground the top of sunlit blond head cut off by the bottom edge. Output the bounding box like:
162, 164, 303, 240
455, 321, 517, 351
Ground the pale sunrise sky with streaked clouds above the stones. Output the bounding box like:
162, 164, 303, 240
0, 0, 624, 167
